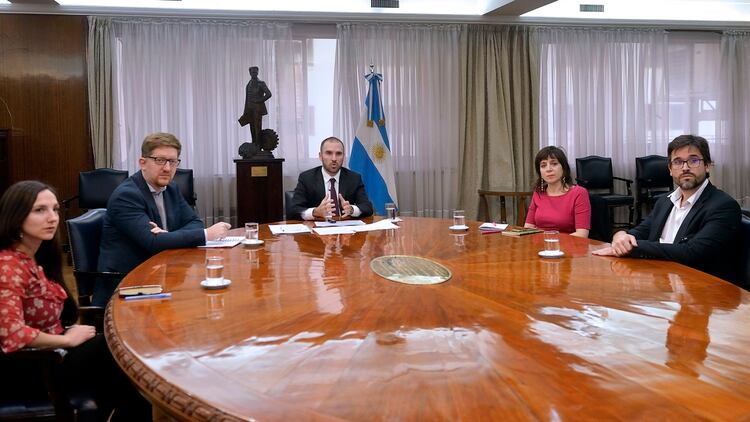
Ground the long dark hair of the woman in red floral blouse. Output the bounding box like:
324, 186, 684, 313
0, 180, 77, 322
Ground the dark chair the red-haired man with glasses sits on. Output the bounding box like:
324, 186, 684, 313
66, 208, 125, 306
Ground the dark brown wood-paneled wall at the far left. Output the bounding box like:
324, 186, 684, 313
0, 14, 93, 200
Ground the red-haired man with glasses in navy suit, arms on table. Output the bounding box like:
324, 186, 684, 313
93, 133, 230, 306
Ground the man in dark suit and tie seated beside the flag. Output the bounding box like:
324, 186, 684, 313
287, 137, 372, 220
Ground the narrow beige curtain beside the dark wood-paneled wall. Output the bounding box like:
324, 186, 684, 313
86, 16, 114, 168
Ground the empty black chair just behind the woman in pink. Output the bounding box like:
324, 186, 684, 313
576, 155, 633, 227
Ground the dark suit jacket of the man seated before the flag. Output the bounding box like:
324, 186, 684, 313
287, 166, 372, 220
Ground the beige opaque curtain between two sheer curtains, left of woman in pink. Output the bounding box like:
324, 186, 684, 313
459, 25, 539, 218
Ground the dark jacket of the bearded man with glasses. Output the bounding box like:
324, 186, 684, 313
628, 182, 742, 283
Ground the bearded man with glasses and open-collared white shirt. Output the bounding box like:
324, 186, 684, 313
593, 135, 741, 283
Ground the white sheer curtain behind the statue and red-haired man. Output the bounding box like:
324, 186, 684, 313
112, 18, 298, 224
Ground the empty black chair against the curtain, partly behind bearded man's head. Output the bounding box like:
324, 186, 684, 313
635, 155, 674, 224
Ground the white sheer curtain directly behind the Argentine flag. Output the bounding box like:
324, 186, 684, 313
333, 23, 460, 217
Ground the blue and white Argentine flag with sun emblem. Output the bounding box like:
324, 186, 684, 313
349, 71, 398, 215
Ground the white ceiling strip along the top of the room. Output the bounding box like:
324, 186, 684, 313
0, 0, 750, 27
